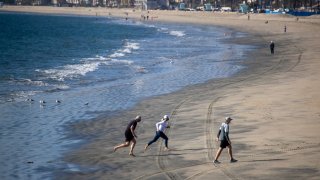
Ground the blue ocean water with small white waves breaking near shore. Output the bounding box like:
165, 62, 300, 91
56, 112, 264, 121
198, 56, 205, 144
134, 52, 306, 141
0, 12, 252, 179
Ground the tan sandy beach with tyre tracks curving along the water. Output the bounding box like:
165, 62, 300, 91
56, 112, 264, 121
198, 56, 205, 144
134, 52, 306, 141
0, 6, 320, 179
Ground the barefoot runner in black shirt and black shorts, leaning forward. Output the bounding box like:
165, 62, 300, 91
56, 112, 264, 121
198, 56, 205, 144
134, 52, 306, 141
113, 116, 141, 156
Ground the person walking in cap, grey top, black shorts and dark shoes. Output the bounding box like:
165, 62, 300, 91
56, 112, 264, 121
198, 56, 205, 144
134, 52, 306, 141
213, 117, 238, 164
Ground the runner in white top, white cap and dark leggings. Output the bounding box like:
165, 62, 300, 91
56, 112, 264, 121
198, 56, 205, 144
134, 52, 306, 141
144, 115, 170, 151
